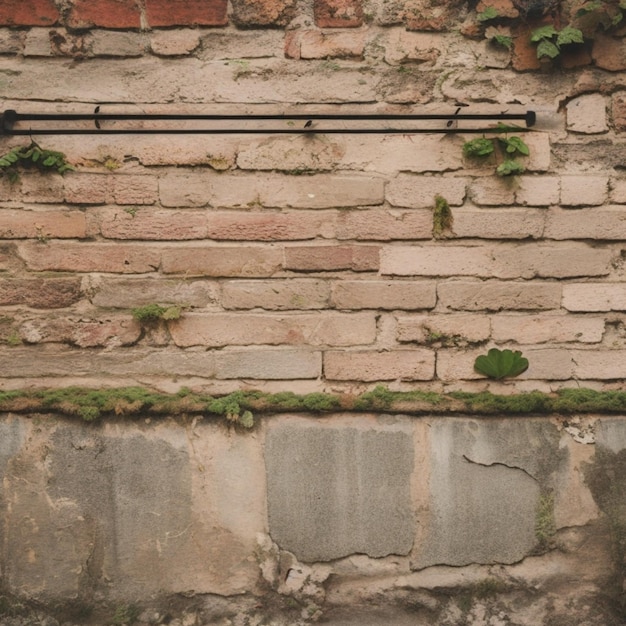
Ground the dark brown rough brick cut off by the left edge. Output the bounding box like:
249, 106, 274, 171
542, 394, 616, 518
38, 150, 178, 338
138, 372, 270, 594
0, 278, 82, 309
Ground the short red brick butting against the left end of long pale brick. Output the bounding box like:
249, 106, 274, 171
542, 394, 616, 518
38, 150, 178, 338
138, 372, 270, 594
285, 246, 380, 272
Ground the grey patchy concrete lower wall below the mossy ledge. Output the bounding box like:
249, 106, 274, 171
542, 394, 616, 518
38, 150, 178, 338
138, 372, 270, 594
0, 414, 626, 626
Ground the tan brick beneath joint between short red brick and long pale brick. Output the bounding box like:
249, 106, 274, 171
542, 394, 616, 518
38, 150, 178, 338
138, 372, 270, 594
331, 280, 437, 310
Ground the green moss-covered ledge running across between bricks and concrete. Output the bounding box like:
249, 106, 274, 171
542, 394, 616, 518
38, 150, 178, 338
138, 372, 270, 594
0, 386, 626, 428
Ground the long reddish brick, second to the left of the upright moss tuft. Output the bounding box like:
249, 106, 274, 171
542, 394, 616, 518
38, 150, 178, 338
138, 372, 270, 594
208, 211, 336, 241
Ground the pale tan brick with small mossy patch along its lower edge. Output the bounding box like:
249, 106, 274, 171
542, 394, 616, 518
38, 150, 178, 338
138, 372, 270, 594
397, 314, 491, 344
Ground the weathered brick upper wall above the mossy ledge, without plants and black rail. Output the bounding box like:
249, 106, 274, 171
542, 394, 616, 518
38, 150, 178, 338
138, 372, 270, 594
0, 0, 626, 392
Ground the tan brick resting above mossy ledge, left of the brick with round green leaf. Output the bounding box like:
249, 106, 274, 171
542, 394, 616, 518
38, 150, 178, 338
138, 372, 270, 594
324, 349, 435, 382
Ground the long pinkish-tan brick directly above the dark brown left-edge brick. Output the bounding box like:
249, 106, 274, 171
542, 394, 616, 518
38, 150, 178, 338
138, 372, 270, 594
19, 242, 160, 274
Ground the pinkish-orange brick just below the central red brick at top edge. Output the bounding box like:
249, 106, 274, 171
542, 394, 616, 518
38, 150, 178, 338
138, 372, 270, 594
285, 30, 366, 59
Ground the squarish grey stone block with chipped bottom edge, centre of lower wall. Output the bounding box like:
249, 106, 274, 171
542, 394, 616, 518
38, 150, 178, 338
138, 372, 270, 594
265, 418, 414, 562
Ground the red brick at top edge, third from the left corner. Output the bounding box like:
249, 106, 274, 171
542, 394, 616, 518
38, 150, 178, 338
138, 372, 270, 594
145, 0, 228, 27
